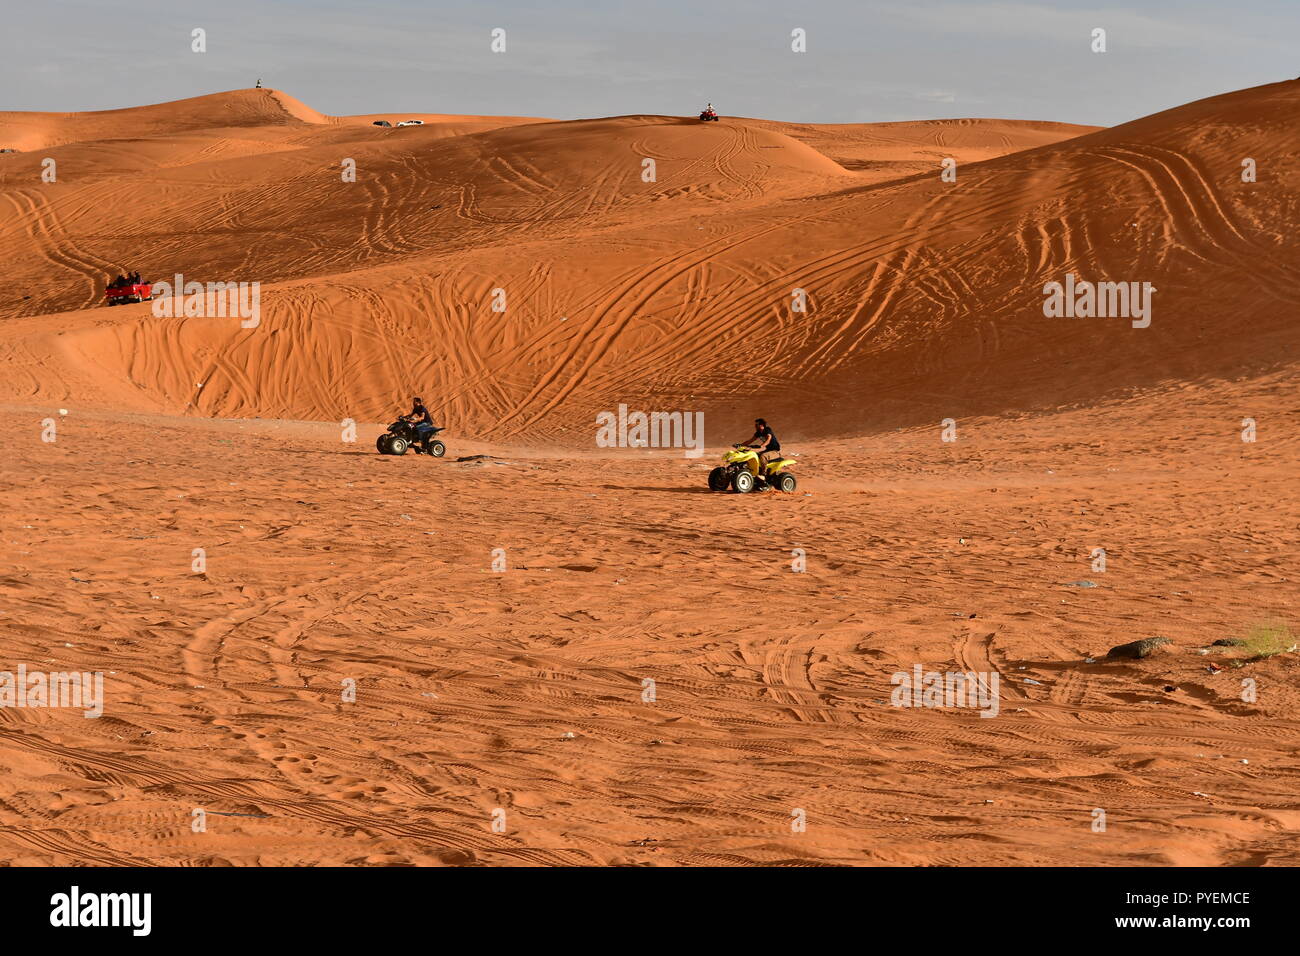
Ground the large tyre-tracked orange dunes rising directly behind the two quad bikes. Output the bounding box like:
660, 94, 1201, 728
3, 83, 1300, 442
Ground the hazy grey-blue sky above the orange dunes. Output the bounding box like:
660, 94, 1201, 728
0, 0, 1300, 126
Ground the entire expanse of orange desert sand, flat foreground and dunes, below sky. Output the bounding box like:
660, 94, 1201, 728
0, 82, 1300, 865
